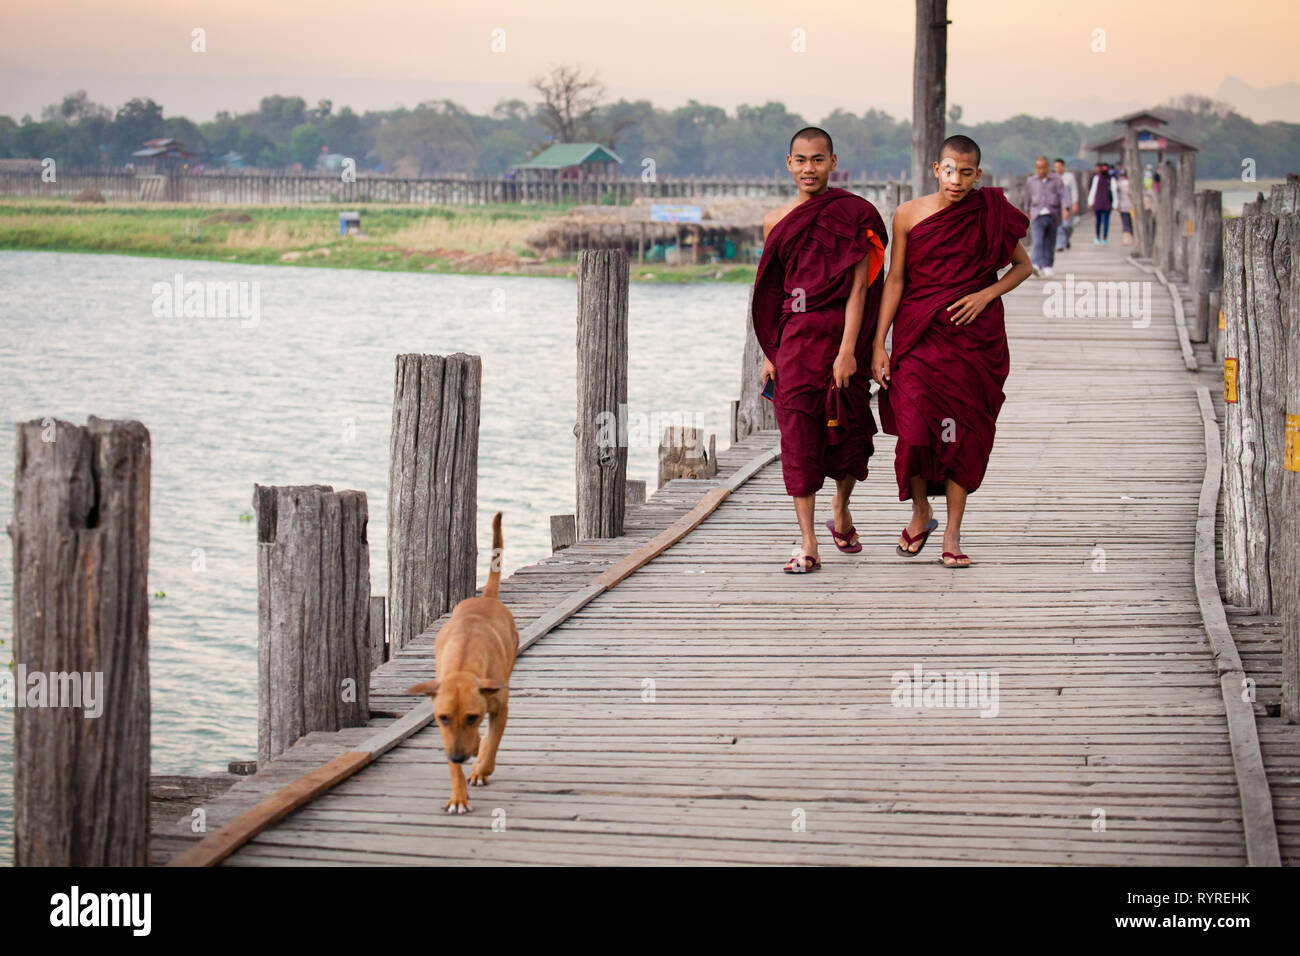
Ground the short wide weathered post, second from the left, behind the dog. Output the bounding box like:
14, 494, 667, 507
252, 485, 373, 766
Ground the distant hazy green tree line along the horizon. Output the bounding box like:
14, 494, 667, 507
0, 79, 1300, 178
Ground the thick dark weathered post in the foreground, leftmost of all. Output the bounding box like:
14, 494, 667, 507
12, 416, 150, 866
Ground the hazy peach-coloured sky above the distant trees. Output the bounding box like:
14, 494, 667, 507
0, 0, 1300, 121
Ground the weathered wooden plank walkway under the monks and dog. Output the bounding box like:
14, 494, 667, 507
155, 230, 1274, 865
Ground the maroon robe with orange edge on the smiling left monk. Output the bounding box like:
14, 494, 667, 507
753, 189, 888, 497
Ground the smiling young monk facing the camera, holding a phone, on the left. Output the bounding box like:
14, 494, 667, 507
753, 126, 888, 574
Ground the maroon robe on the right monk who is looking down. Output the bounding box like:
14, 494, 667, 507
879, 187, 1030, 501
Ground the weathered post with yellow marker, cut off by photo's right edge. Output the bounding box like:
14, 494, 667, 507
1278, 213, 1300, 723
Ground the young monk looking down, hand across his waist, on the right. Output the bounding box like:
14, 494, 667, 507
871, 137, 1034, 568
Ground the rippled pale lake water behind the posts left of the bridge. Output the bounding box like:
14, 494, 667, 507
0, 251, 749, 864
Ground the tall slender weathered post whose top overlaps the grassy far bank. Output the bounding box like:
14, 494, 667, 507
573, 250, 628, 540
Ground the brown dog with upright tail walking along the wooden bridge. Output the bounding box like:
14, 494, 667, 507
407, 511, 519, 813
